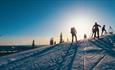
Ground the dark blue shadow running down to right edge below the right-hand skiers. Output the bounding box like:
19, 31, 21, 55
90, 39, 115, 57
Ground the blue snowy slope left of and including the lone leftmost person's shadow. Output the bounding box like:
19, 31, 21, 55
0, 44, 77, 70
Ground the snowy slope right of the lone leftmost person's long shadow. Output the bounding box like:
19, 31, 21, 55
72, 35, 115, 70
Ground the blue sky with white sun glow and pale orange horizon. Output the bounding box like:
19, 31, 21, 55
0, 0, 115, 45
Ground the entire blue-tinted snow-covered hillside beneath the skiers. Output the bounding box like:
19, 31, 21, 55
0, 35, 115, 70
